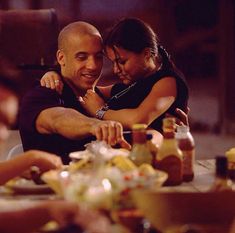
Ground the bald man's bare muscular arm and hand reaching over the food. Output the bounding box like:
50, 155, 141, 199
36, 107, 130, 148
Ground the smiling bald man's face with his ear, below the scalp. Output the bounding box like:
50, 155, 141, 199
57, 35, 103, 95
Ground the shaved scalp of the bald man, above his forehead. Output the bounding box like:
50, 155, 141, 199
58, 21, 101, 50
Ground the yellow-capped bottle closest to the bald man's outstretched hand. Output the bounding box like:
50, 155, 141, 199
129, 124, 152, 166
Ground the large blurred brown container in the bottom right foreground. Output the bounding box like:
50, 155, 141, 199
131, 190, 235, 232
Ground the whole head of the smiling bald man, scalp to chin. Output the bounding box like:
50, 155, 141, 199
57, 21, 103, 96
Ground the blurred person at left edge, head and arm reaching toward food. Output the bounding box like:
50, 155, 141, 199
0, 58, 62, 185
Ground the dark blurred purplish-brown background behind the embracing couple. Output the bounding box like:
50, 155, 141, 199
0, 0, 235, 158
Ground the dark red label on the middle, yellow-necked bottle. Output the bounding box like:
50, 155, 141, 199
156, 155, 183, 185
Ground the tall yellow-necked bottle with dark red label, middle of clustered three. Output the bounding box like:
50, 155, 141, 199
156, 117, 183, 185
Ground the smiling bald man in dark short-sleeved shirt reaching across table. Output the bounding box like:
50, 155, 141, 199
19, 21, 129, 163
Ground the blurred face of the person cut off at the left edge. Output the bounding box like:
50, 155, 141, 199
0, 86, 18, 142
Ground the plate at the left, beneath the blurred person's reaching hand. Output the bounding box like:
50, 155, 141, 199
5, 178, 53, 194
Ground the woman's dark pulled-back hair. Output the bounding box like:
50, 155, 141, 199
104, 18, 173, 68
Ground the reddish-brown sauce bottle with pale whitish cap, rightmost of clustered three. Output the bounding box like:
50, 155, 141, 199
176, 125, 195, 182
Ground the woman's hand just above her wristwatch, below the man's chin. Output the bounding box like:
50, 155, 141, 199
81, 90, 105, 117
